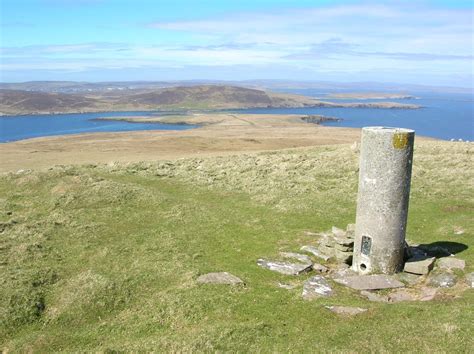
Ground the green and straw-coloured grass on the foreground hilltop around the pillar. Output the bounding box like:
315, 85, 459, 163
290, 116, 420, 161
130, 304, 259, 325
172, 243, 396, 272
0, 143, 474, 352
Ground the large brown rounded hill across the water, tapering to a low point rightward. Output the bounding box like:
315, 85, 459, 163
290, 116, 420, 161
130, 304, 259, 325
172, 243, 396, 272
0, 85, 420, 115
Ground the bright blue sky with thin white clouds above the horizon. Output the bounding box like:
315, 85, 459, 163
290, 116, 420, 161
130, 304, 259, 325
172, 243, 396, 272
0, 0, 474, 87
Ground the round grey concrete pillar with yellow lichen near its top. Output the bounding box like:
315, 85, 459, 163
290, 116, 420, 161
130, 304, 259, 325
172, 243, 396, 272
352, 127, 415, 274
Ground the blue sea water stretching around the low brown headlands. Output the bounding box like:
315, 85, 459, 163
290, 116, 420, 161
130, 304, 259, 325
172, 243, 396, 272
0, 89, 474, 143
